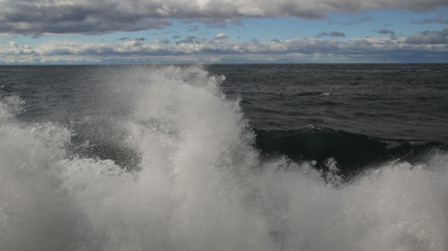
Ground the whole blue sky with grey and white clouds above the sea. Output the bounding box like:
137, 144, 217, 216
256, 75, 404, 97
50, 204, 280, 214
0, 0, 448, 64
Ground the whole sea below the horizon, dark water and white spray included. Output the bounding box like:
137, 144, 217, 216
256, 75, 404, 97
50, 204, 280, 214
0, 64, 448, 251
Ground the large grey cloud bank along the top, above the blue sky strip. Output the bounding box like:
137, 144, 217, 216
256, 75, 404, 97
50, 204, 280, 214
0, 0, 448, 34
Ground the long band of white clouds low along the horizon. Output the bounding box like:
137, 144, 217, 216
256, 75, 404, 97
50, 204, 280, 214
0, 33, 448, 63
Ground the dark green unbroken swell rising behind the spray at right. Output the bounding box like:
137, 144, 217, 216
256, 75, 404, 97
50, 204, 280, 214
255, 126, 448, 178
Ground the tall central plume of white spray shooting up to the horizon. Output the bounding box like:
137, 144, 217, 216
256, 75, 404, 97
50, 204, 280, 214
58, 67, 269, 250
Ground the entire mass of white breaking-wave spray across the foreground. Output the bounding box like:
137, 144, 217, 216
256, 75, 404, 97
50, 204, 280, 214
0, 66, 448, 251
